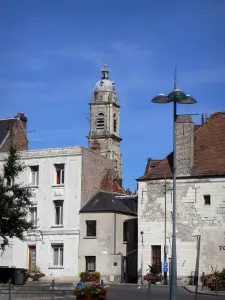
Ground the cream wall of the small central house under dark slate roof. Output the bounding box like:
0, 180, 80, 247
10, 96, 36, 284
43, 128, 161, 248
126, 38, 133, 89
79, 213, 133, 282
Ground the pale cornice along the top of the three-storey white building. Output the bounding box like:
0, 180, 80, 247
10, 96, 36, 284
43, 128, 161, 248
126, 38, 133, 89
0, 146, 81, 161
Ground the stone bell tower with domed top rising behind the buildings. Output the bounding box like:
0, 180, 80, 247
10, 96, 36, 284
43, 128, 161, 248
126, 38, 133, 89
87, 65, 122, 182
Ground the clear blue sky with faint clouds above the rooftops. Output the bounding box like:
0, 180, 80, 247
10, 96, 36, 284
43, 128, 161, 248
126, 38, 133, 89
0, 0, 225, 189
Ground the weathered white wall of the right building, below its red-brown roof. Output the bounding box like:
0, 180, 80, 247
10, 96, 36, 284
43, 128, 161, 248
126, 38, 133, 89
138, 178, 225, 284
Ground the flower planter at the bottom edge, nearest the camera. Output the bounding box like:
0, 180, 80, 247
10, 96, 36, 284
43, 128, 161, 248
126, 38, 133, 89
74, 284, 106, 300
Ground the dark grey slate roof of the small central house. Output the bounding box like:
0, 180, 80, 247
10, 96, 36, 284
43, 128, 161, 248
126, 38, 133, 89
80, 191, 137, 216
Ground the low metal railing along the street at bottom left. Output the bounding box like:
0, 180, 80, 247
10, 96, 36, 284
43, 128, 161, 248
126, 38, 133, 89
0, 280, 75, 300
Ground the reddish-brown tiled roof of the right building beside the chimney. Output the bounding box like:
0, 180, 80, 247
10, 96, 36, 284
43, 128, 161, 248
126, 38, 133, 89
138, 112, 225, 180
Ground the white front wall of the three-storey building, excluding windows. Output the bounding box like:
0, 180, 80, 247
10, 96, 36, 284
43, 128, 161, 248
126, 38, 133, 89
0, 147, 82, 279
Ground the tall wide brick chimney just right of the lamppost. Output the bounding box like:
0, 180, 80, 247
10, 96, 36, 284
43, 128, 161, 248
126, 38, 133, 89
176, 116, 194, 176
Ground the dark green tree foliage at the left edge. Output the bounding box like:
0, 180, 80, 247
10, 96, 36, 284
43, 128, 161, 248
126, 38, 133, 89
0, 146, 33, 250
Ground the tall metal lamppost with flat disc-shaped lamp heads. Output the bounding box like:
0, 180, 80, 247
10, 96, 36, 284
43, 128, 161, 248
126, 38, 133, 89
152, 68, 197, 300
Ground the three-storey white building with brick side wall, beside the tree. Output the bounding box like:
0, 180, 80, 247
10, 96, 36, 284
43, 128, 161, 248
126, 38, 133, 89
0, 147, 113, 280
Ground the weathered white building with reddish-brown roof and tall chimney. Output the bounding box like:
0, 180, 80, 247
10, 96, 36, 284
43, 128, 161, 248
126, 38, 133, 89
138, 113, 225, 282
